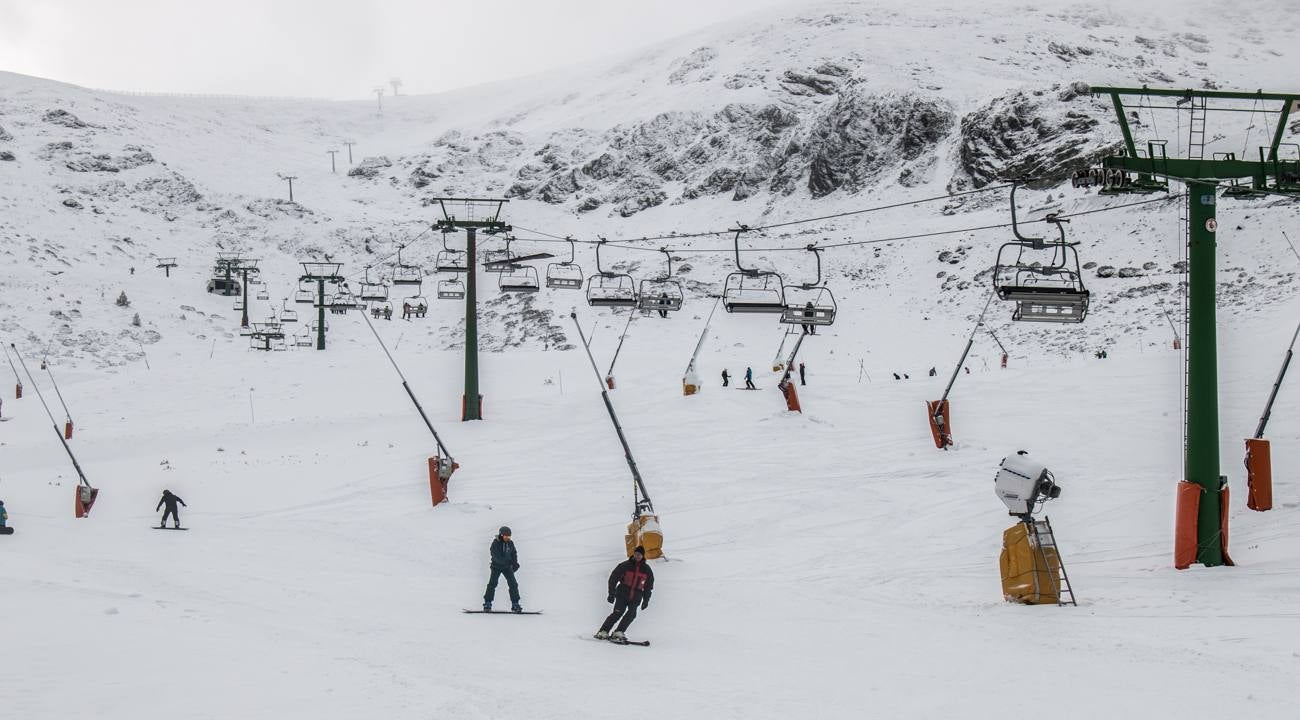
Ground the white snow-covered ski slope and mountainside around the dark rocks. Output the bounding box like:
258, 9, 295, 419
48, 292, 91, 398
0, 3, 1300, 719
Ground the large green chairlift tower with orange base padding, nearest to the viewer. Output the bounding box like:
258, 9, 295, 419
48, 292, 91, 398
1091, 87, 1300, 569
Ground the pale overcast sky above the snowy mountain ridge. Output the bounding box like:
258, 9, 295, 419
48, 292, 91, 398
0, 0, 806, 99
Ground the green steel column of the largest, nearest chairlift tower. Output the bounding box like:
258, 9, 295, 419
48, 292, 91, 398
1187, 182, 1223, 565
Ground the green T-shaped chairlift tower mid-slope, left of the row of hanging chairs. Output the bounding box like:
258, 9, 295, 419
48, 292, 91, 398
434, 198, 511, 421
